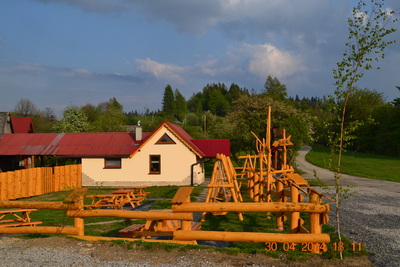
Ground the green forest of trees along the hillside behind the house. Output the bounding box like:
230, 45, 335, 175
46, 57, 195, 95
12, 76, 400, 160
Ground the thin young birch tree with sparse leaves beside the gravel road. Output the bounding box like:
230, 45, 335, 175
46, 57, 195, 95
331, 0, 397, 259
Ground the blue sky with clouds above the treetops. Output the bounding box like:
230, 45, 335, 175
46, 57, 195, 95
0, 0, 400, 115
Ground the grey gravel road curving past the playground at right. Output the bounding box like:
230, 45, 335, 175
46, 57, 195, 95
297, 147, 400, 266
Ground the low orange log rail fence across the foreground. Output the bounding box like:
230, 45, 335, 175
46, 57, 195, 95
0, 187, 330, 253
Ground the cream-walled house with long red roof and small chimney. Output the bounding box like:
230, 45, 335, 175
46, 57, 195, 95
0, 119, 230, 186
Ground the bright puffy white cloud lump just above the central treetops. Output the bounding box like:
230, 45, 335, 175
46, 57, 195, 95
238, 44, 307, 79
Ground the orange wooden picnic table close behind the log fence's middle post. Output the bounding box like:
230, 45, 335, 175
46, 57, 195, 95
119, 209, 201, 237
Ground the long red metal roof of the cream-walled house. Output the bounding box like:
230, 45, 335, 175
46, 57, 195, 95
0, 122, 230, 157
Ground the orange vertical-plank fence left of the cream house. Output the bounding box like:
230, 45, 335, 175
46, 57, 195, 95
0, 164, 82, 200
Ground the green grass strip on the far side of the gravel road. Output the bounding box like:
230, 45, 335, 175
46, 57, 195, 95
306, 146, 400, 182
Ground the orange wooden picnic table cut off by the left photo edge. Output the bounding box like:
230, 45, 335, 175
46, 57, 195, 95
0, 208, 42, 227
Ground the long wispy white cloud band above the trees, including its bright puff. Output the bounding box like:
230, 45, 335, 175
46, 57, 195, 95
136, 43, 308, 85
